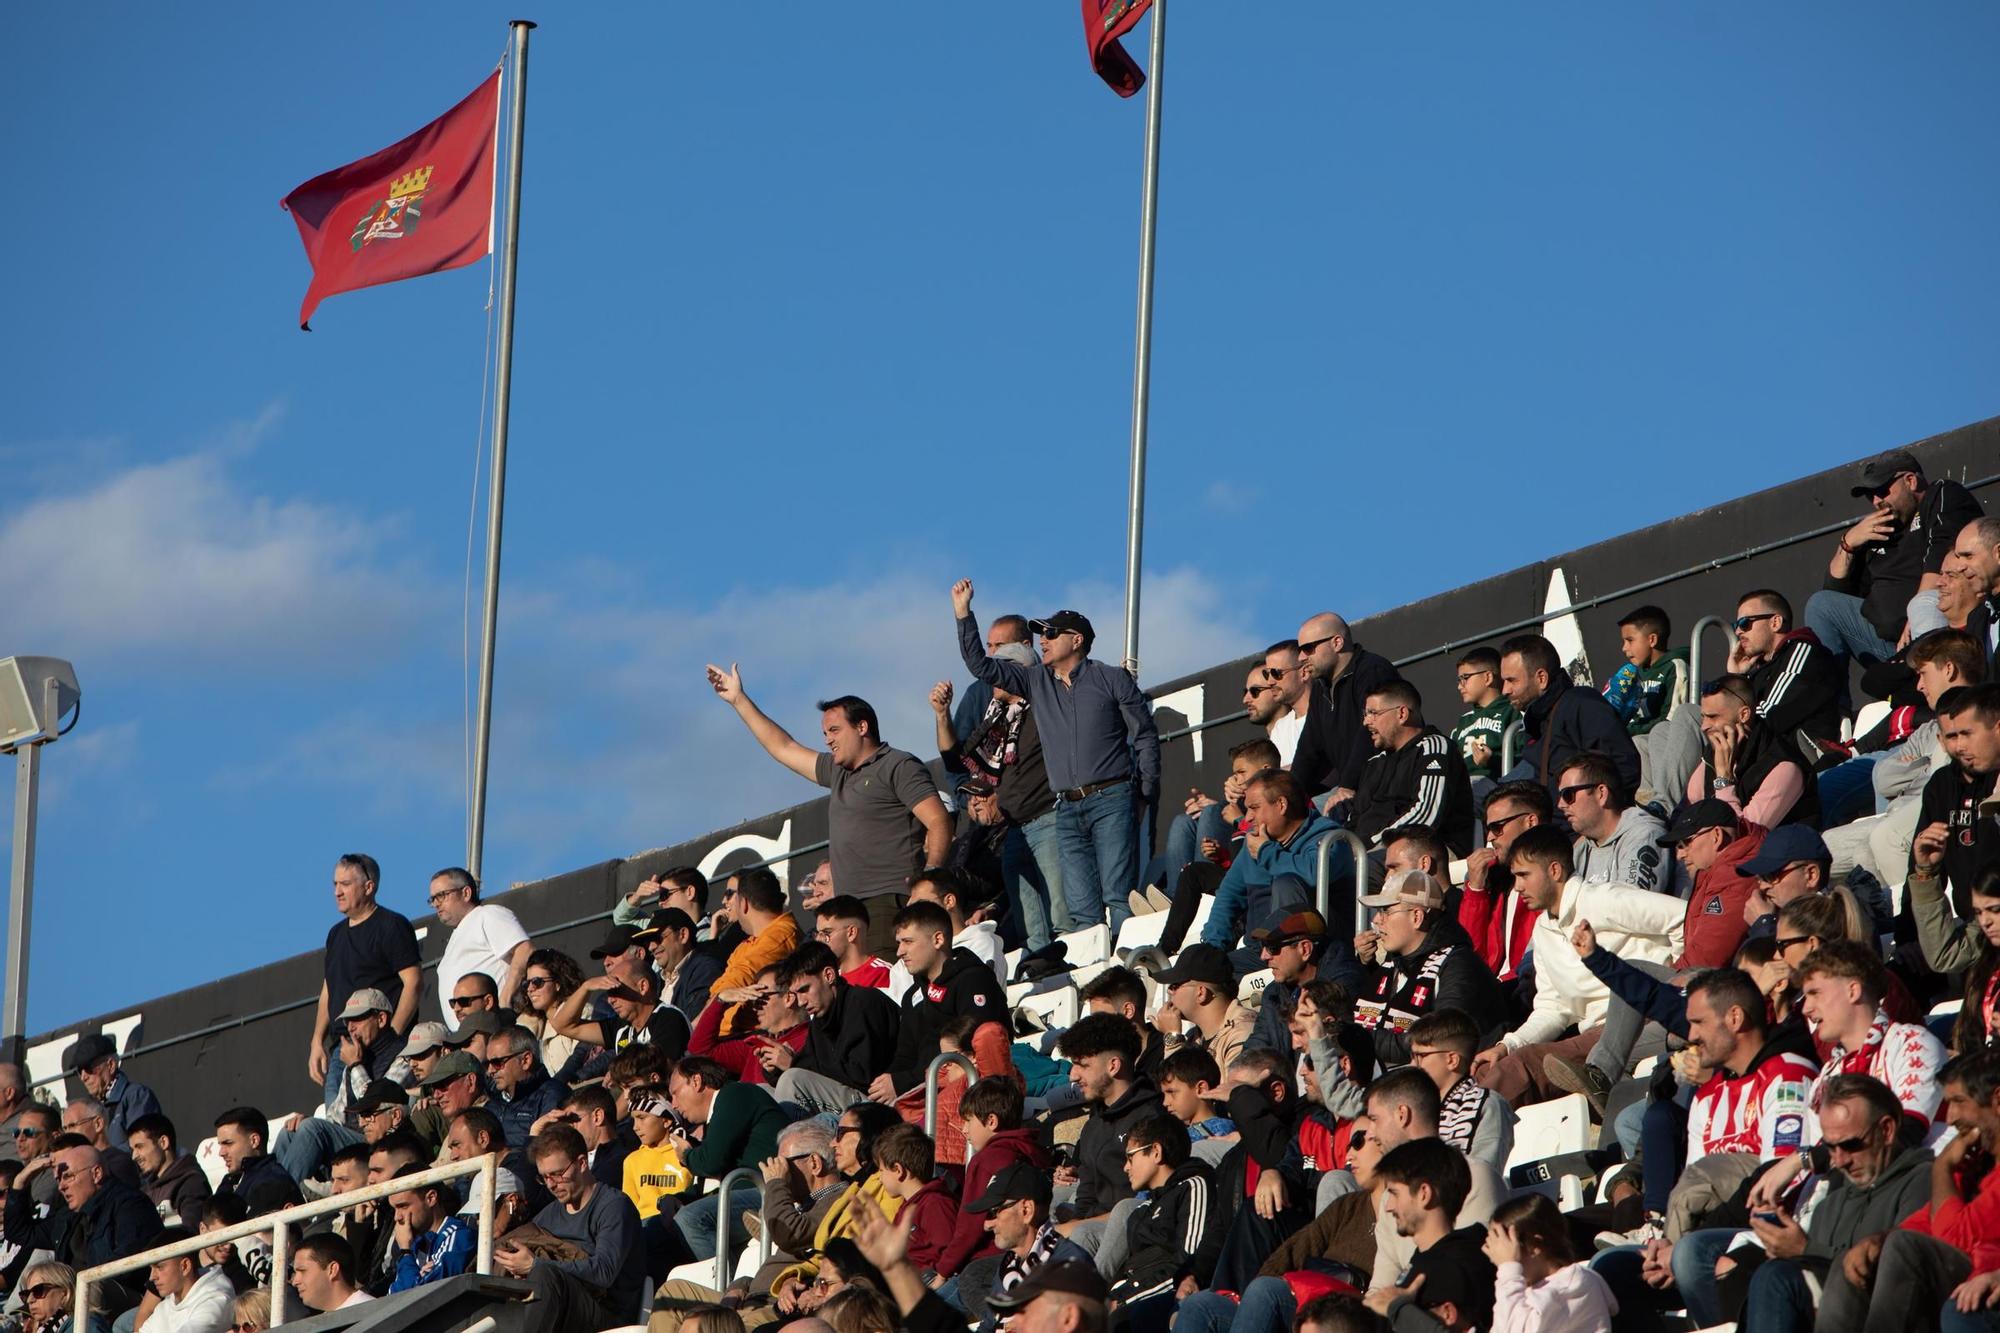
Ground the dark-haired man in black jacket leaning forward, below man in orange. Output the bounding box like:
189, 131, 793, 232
758, 941, 914, 1113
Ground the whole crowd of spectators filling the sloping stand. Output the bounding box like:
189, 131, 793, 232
0, 450, 2000, 1333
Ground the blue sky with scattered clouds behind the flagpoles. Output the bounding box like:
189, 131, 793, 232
0, 0, 2000, 1031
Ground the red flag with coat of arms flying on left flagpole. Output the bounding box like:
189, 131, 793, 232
284, 70, 500, 328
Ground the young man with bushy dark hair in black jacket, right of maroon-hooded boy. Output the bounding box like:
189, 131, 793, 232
1056, 1013, 1186, 1273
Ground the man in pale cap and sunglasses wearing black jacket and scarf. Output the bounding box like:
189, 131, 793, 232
1354, 871, 1508, 1069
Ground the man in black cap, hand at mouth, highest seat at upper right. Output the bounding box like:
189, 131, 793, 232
1806, 448, 1982, 662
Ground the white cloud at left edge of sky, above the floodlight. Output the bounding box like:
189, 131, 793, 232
0, 406, 428, 675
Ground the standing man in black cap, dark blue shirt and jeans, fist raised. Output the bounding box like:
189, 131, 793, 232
952, 578, 1160, 937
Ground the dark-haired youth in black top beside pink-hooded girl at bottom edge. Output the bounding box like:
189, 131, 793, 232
1366, 1139, 1498, 1333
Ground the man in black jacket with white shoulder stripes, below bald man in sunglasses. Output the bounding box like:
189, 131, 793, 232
1348, 681, 1472, 857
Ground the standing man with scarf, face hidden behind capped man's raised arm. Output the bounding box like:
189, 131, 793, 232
930, 634, 1072, 951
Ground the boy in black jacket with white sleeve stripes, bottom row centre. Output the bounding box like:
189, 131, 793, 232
1112, 1115, 1224, 1333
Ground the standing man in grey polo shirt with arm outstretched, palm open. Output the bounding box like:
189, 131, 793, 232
708, 664, 952, 955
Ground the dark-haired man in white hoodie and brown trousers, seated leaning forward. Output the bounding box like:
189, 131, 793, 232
1472, 827, 1688, 1107
